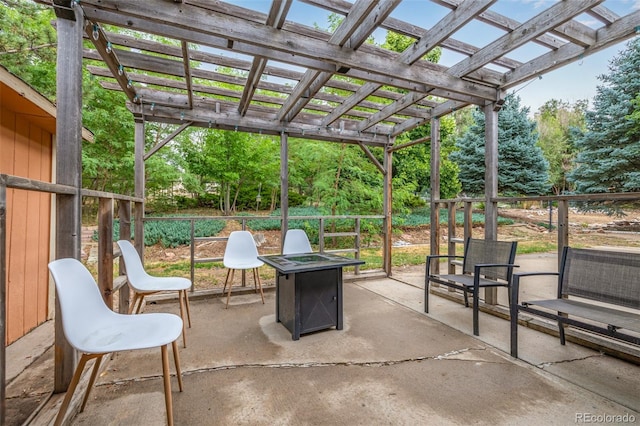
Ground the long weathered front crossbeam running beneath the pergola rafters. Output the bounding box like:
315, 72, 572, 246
82, 0, 495, 100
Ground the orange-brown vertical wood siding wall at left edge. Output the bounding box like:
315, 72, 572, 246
0, 106, 53, 344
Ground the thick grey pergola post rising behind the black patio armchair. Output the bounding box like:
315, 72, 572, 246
484, 103, 498, 305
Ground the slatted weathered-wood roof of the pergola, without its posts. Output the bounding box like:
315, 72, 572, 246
43, 0, 640, 146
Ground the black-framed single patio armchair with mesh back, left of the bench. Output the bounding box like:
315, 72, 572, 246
424, 238, 518, 336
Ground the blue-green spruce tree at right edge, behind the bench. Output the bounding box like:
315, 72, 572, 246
569, 38, 640, 193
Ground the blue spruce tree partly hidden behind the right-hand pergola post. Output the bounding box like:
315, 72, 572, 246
449, 94, 549, 196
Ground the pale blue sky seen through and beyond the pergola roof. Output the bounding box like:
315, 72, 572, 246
226, 0, 640, 114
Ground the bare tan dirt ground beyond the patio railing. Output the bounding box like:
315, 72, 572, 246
110, 209, 640, 289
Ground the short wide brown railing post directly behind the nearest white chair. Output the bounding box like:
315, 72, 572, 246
98, 198, 113, 310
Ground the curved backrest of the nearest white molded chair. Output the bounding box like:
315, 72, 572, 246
49, 258, 117, 351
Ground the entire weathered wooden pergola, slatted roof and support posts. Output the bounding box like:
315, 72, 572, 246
37, 0, 640, 404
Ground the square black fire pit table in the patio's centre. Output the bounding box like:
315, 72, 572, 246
258, 253, 364, 340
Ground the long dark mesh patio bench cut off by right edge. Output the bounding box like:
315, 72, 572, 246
510, 247, 640, 358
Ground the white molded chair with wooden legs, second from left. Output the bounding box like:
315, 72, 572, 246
118, 240, 191, 348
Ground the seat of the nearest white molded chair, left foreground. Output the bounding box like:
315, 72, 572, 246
78, 313, 182, 354
